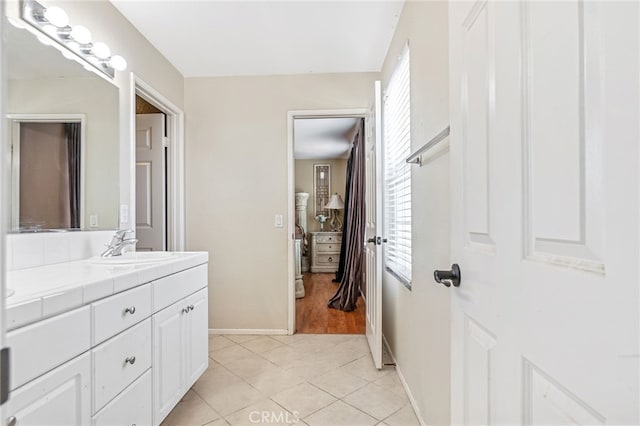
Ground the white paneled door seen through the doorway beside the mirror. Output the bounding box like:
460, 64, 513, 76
136, 114, 166, 251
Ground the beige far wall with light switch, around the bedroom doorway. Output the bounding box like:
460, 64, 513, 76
185, 73, 376, 330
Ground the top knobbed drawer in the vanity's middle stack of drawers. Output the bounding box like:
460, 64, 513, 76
91, 284, 151, 346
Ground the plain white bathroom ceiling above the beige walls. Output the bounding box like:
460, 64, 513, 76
111, 0, 404, 77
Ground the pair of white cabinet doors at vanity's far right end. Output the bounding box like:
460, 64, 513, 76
152, 288, 208, 425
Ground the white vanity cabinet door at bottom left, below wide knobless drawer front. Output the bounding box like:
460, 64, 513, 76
6, 353, 91, 426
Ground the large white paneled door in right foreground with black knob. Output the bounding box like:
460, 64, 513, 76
449, 1, 640, 425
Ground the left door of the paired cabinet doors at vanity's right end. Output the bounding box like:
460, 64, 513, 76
151, 301, 187, 425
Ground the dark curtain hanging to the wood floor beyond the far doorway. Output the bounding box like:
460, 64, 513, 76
329, 120, 365, 312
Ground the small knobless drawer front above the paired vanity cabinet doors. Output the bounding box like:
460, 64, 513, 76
152, 265, 208, 312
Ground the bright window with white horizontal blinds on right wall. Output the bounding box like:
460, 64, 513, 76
383, 46, 411, 288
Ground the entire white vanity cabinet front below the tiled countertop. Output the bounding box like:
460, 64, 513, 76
5, 258, 209, 426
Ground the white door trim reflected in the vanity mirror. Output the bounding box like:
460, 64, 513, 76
7, 114, 90, 231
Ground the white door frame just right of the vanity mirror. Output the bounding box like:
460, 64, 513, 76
129, 73, 185, 251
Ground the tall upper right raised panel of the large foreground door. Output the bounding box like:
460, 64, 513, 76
521, 2, 605, 273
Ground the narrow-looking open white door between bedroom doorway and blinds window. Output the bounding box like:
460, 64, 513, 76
365, 81, 382, 368
